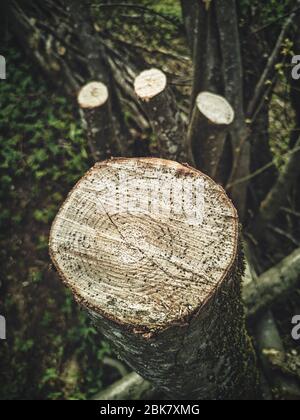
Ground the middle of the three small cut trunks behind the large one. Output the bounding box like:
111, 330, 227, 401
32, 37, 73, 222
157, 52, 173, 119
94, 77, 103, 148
134, 69, 186, 161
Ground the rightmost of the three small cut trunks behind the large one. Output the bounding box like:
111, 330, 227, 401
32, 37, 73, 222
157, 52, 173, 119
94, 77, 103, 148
187, 92, 234, 179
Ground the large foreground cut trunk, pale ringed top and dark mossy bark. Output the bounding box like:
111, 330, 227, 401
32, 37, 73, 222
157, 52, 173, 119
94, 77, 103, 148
50, 159, 257, 399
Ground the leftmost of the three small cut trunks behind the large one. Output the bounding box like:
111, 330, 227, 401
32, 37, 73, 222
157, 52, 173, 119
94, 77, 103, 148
77, 82, 113, 162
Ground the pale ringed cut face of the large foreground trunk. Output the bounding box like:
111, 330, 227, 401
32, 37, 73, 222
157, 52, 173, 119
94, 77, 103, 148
50, 158, 238, 333
